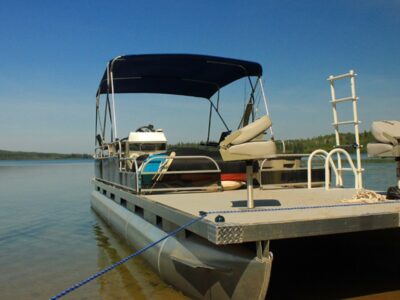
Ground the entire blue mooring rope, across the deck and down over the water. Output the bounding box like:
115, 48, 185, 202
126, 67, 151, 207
50, 200, 399, 300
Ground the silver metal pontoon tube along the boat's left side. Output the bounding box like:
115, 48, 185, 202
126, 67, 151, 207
91, 191, 272, 299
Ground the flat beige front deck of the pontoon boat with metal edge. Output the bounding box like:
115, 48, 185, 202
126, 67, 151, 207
145, 188, 400, 244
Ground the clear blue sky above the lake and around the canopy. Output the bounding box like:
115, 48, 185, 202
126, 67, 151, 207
0, 0, 400, 153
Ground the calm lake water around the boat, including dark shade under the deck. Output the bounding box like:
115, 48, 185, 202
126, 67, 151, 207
0, 161, 400, 299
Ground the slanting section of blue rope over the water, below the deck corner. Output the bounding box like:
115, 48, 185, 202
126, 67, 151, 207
50, 213, 207, 300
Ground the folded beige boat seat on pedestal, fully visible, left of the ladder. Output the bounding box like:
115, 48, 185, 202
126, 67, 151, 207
219, 116, 276, 208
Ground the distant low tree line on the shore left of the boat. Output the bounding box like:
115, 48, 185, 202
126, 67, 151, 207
0, 150, 92, 160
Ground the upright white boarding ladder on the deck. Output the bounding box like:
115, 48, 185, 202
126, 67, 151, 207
325, 70, 363, 189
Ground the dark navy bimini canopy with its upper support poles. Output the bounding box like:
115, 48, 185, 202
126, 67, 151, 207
96, 54, 274, 145
